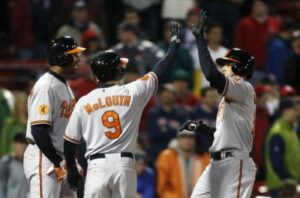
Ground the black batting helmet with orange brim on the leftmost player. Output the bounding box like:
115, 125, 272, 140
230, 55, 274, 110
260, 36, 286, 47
47, 36, 85, 67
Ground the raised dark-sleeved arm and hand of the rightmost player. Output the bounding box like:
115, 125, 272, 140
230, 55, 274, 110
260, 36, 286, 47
192, 10, 226, 94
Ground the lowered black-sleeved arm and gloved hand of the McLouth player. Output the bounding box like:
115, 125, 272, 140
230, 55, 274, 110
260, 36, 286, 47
64, 140, 83, 191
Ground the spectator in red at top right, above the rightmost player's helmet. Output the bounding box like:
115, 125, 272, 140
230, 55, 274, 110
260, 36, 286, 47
235, 0, 279, 71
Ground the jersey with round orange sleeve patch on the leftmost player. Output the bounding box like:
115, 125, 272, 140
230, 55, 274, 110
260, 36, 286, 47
26, 72, 75, 152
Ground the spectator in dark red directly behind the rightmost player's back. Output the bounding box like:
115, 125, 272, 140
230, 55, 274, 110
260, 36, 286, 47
252, 84, 271, 180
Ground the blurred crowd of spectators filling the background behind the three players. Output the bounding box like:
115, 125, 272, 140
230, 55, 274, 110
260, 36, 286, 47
0, 0, 300, 198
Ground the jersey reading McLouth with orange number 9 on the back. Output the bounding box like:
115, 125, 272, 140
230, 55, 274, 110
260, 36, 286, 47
64, 72, 158, 157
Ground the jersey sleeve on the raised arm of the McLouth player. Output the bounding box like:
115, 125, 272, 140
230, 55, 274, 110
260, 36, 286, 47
130, 72, 158, 106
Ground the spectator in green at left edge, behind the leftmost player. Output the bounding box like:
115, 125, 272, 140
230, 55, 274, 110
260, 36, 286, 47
0, 92, 27, 157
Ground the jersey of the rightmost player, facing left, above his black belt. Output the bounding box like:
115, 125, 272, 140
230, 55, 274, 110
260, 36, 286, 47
209, 76, 256, 153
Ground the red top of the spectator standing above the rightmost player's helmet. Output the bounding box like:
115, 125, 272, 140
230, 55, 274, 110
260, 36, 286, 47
235, 16, 280, 70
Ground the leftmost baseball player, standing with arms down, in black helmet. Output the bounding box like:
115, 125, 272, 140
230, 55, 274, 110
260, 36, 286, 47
24, 36, 84, 198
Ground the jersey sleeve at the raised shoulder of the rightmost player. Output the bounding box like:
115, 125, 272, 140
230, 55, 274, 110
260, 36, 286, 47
222, 76, 252, 103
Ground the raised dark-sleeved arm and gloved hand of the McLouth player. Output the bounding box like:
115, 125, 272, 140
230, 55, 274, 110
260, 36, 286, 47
152, 22, 181, 78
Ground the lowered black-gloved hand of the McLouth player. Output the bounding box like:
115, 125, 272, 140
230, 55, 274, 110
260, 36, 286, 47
67, 166, 83, 191
